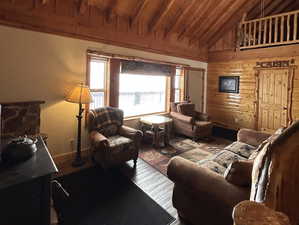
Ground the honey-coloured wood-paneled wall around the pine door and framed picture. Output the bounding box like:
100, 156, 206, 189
207, 55, 299, 129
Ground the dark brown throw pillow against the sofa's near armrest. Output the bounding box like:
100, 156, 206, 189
224, 160, 253, 187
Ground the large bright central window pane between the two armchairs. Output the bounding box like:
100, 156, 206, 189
119, 73, 168, 117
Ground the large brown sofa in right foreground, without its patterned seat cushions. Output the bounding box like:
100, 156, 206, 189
167, 122, 299, 225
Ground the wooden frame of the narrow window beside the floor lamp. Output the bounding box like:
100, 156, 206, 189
85, 53, 109, 112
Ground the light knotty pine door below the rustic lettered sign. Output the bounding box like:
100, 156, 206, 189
258, 68, 289, 133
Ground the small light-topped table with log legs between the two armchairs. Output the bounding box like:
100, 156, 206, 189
140, 115, 172, 148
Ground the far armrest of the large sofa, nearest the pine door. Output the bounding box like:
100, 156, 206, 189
238, 128, 271, 147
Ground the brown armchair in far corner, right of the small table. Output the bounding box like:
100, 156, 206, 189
170, 102, 213, 140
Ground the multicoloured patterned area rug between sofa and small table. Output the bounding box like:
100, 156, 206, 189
139, 137, 231, 175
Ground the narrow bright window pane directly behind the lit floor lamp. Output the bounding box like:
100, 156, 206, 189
88, 56, 107, 109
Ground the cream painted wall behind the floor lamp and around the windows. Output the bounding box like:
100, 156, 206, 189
0, 26, 207, 155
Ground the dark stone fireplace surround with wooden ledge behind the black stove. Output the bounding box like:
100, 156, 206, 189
0, 101, 45, 138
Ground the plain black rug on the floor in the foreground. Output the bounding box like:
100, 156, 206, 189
58, 167, 175, 225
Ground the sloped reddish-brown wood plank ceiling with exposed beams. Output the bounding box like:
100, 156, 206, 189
0, 0, 298, 61
